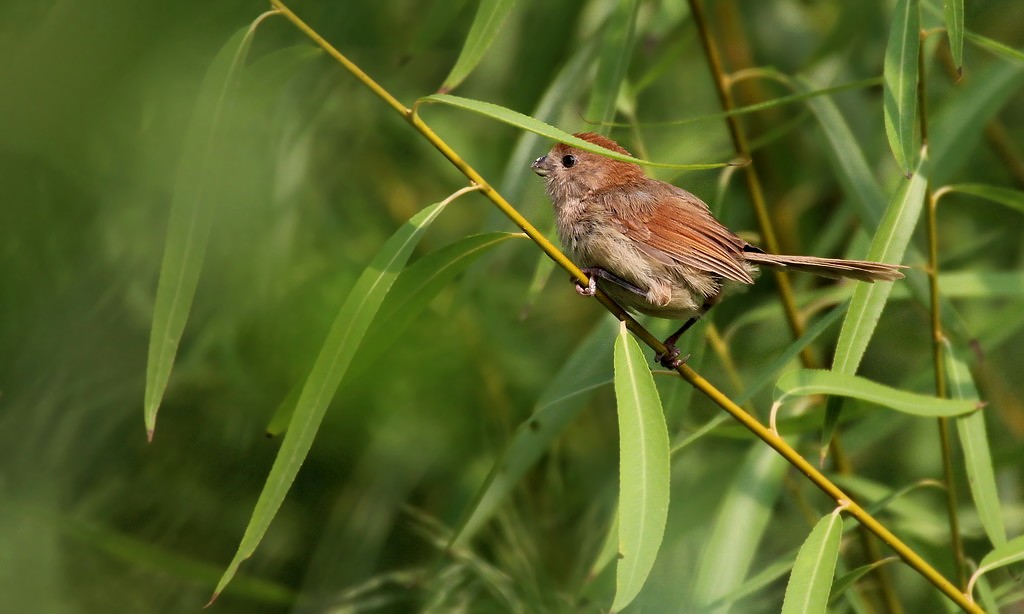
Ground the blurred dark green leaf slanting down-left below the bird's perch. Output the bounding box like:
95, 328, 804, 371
453, 317, 618, 547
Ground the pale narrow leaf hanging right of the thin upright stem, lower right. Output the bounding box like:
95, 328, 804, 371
942, 343, 1007, 547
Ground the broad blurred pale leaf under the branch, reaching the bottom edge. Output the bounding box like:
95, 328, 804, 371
693, 442, 788, 611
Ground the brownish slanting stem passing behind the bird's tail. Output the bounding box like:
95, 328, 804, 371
689, 0, 901, 612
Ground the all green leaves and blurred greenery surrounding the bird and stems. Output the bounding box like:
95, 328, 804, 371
0, 0, 1024, 613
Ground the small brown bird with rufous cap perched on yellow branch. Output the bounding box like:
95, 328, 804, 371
532, 132, 904, 368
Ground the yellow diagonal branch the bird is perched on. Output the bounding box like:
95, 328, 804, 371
270, 0, 984, 613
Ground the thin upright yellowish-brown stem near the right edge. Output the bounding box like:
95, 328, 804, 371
918, 32, 967, 589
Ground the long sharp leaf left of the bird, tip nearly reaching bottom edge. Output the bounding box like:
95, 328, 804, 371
211, 199, 452, 601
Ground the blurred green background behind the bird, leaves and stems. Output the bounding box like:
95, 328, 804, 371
0, 0, 1024, 612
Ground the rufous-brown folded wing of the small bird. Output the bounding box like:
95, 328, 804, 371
609, 183, 754, 283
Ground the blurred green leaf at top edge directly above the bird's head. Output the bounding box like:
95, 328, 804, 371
585, 0, 640, 133
